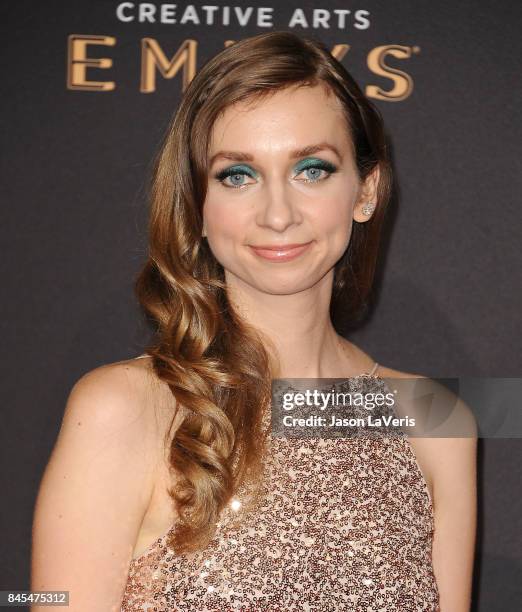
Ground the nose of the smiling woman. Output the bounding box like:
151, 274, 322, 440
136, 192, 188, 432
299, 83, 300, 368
256, 181, 301, 232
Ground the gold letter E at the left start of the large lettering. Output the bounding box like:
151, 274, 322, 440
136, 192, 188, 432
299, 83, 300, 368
67, 34, 116, 91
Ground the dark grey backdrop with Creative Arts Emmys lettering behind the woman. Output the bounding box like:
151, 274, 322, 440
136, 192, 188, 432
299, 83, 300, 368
0, 0, 522, 612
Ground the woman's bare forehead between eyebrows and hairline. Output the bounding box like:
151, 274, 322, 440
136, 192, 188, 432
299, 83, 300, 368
210, 85, 350, 155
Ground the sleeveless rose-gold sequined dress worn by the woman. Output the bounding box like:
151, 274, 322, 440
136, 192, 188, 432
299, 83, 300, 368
121, 364, 439, 612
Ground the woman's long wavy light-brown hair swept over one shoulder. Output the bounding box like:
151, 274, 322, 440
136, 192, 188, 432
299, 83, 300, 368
135, 31, 392, 554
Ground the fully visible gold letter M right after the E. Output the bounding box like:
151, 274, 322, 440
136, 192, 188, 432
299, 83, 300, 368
140, 38, 198, 93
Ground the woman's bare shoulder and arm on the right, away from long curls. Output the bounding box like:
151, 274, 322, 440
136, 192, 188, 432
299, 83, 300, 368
378, 366, 478, 610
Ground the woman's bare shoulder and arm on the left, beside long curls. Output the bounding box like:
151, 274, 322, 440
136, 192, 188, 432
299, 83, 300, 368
31, 359, 177, 610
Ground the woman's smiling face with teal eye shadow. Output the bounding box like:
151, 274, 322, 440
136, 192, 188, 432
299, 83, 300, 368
203, 85, 375, 295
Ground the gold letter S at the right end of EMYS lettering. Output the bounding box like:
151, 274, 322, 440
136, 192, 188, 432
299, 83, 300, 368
366, 45, 413, 102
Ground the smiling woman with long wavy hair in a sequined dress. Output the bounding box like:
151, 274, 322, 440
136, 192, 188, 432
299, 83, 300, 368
32, 32, 475, 612
